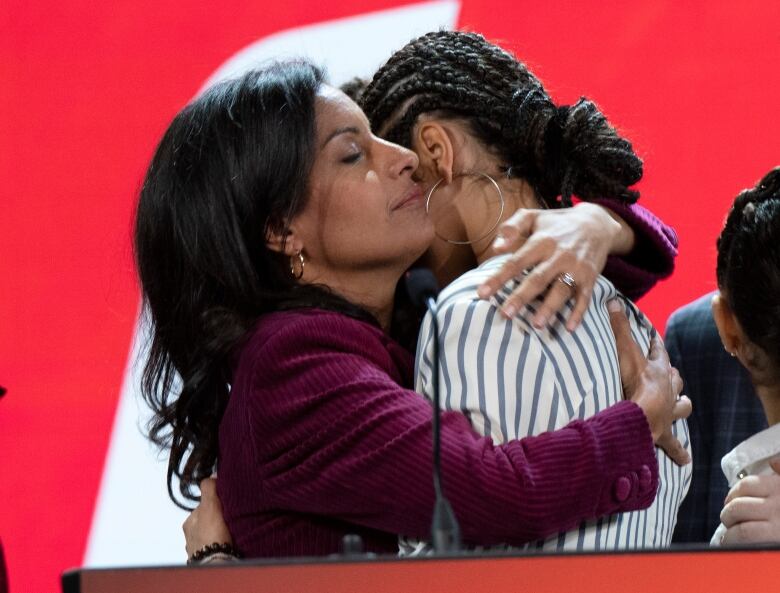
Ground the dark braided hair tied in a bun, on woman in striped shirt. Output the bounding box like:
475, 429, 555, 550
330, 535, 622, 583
359, 31, 642, 207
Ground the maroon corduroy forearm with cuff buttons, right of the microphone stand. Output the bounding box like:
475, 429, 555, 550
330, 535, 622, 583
443, 402, 658, 545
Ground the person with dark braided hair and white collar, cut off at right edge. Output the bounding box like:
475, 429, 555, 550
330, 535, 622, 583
712, 167, 780, 545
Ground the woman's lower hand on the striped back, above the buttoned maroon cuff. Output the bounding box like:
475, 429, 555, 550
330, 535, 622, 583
607, 300, 693, 465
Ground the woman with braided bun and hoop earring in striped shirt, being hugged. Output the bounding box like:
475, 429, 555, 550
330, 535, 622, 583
360, 31, 691, 551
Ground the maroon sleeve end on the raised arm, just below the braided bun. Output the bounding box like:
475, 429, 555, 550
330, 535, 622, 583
593, 199, 677, 300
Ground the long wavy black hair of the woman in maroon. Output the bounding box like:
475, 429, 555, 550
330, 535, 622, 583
135, 62, 373, 506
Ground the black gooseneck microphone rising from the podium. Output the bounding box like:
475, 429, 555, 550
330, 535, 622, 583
405, 268, 460, 554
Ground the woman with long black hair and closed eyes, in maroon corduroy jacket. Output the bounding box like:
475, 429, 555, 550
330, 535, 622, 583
135, 57, 685, 556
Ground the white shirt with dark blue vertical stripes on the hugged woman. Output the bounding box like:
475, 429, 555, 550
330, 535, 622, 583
400, 256, 691, 554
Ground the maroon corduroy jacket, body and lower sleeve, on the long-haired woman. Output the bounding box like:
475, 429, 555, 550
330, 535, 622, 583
218, 309, 658, 557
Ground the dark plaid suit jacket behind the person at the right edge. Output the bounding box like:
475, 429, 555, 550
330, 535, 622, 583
666, 293, 767, 543
